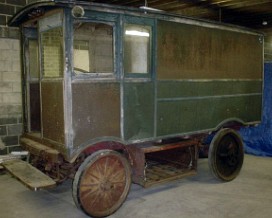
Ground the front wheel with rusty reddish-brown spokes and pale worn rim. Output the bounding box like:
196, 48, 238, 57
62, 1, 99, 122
73, 150, 131, 217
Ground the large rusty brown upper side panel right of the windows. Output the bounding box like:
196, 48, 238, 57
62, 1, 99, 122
157, 20, 263, 79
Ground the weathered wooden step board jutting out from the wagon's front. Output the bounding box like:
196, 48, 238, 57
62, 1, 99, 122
2, 159, 56, 191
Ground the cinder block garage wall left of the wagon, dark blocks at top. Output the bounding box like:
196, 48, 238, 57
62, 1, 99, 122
0, 0, 26, 154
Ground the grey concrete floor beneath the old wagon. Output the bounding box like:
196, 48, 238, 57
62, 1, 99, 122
0, 155, 272, 218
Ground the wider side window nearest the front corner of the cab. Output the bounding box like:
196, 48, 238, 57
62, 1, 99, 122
73, 22, 114, 75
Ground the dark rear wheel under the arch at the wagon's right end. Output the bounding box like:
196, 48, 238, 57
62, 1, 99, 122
208, 129, 244, 181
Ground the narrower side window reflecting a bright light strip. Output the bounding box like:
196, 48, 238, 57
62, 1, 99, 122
124, 24, 151, 74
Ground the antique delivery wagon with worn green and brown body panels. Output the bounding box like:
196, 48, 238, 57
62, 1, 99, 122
4, 0, 263, 217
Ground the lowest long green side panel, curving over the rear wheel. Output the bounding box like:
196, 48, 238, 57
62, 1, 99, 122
157, 95, 262, 136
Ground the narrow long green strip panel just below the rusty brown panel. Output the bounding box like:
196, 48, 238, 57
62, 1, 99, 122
158, 80, 262, 98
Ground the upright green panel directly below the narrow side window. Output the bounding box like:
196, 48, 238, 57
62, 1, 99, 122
124, 83, 154, 140
